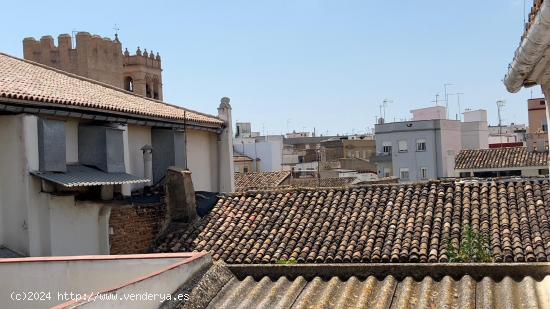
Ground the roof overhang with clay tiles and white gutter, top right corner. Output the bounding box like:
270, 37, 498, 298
504, 1, 550, 93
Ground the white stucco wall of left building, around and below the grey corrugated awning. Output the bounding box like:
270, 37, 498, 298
0, 115, 113, 256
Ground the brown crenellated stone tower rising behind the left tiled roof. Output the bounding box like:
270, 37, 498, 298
23, 32, 162, 100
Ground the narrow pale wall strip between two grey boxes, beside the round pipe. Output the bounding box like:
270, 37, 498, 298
127, 125, 154, 190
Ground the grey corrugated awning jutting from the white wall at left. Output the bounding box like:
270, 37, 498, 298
31, 165, 150, 187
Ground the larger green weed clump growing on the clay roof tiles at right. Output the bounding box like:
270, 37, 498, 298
447, 225, 493, 263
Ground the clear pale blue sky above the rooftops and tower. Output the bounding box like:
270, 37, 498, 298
0, 0, 541, 134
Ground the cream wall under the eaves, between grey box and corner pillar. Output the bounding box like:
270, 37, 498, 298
187, 130, 218, 192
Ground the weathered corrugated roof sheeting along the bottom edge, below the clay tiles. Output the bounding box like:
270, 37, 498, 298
207, 275, 550, 309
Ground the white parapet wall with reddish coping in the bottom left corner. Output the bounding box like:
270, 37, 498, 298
0, 253, 212, 309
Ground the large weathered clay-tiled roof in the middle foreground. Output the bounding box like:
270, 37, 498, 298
155, 180, 550, 264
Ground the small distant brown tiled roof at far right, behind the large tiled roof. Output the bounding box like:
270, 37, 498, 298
455, 147, 548, 169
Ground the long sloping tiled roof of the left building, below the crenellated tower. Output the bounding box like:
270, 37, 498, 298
0, 53, 223, 126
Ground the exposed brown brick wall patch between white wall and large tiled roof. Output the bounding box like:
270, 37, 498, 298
109, 204, 167, 254
